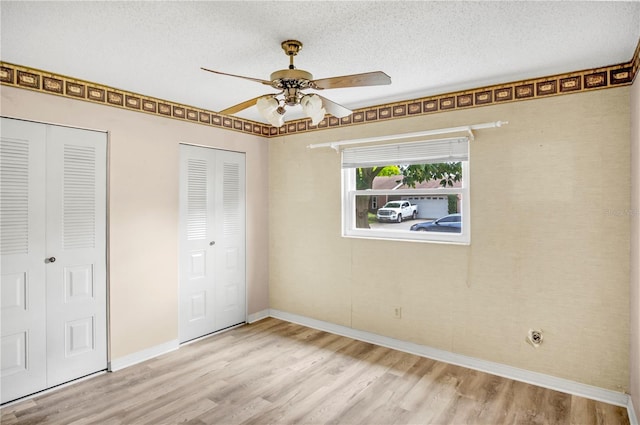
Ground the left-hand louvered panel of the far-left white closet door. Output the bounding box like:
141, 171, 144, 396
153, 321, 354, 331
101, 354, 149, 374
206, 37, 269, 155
0, 118, 47, 402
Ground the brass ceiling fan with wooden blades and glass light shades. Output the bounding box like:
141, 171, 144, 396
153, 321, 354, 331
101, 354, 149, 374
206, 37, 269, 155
201, 40, 391, 127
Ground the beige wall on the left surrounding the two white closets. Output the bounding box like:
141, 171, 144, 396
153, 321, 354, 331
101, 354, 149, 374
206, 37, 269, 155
1, 86, 268, 360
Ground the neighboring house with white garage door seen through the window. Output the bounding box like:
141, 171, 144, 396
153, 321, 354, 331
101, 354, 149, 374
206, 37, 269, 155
369, 176, 461, 219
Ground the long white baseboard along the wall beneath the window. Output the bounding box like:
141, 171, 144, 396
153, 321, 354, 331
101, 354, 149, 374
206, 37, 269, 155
270, 309, 637, 408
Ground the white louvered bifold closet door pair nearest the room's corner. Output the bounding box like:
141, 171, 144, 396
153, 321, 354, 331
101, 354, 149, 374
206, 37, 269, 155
179, 145, 246, 342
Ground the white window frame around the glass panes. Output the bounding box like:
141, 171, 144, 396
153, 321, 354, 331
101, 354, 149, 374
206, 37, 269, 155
341, 139, 471, 245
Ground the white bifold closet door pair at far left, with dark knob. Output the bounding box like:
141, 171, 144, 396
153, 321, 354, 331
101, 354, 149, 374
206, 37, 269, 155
0, 118, 107, 402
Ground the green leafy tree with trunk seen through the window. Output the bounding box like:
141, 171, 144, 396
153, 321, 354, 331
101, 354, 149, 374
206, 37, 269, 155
356, 162, 462, 229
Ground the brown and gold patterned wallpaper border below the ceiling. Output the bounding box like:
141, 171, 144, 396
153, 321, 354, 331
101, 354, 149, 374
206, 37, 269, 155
0, 41, 640, 137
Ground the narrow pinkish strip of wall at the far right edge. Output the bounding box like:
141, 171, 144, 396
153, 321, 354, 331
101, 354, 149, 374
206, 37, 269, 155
629, 76, 640, 418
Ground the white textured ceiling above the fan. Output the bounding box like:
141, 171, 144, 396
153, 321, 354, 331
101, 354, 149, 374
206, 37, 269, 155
0, 0, 640, 122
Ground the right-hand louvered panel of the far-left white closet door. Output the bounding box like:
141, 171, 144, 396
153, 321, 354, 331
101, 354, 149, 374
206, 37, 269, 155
46, 126, 107, 386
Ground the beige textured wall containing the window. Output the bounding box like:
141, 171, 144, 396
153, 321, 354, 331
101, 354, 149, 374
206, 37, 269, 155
269, 87, 630, 391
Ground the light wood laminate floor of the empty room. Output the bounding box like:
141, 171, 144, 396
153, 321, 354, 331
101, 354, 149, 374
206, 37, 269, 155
0, 318, 629, 425
